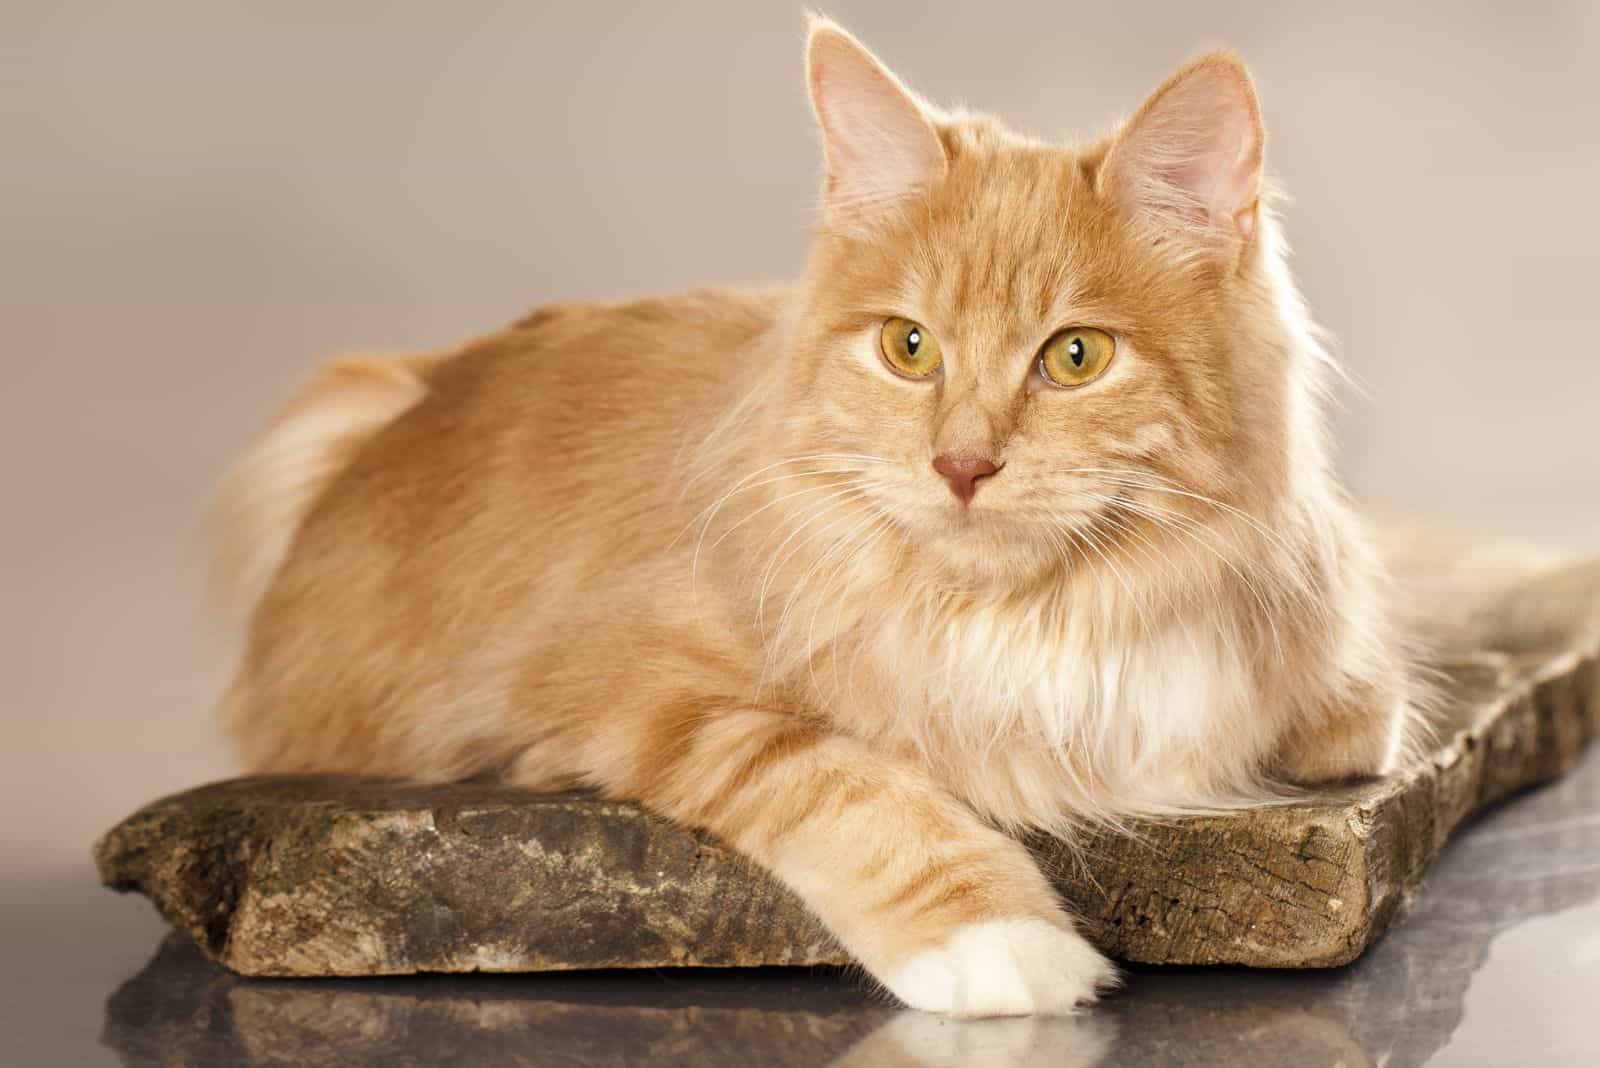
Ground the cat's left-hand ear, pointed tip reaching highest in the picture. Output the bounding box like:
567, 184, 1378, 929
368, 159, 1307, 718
806, 18, 947, 224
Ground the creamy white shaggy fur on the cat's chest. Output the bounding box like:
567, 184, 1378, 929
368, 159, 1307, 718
870, 606, 1267, 825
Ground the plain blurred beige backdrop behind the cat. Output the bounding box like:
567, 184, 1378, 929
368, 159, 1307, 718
0, 0, 1600, 889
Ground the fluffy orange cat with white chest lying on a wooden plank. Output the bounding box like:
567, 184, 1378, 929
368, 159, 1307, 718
218, 21, 1413, 1015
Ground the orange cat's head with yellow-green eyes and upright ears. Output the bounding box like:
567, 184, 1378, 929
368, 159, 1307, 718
784, 21, 1317, 585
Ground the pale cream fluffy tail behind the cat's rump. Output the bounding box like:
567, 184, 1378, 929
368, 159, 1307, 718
210, 355, 440, 624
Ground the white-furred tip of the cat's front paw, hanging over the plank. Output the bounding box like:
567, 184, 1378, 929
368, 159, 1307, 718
885, 919, 1117, 1017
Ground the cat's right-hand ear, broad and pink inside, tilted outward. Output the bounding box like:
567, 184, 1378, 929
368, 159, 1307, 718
1099, 51, 1266, 256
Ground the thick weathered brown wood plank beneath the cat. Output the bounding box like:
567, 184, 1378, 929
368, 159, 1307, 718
96, 638, 1600, 975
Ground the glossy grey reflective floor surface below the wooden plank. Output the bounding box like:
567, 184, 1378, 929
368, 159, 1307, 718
0, 741, 1600, 1068
